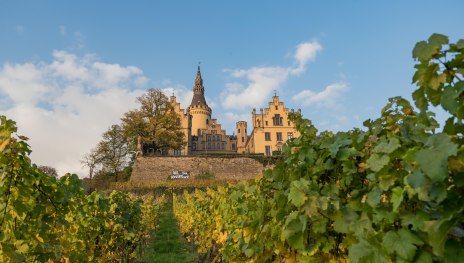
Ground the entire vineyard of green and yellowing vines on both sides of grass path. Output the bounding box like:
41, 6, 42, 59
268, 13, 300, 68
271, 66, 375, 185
0, 34, 464, 262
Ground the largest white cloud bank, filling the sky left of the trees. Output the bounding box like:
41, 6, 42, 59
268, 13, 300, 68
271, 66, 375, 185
0, 51, 147, 176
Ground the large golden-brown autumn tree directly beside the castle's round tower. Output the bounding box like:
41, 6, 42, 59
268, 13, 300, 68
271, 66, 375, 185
121, 89, 184, 154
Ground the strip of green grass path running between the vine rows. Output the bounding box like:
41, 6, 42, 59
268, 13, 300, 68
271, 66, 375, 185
138, 203, 196, 263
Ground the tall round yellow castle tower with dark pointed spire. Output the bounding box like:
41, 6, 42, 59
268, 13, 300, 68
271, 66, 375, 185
187, 65, 211, 136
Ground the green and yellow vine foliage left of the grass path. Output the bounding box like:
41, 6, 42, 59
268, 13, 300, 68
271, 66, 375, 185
0, 116, 164, 262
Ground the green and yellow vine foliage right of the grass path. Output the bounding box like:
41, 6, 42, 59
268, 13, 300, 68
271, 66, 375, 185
174, 34, 464, 262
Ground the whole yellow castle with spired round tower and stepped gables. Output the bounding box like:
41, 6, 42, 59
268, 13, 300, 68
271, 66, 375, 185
165, 66, 301, 156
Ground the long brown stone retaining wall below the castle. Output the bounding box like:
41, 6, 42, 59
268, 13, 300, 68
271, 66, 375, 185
130, 157, 264, 182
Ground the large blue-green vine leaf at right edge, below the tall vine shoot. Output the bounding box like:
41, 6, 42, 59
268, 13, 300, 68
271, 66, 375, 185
415, 133, 458, 182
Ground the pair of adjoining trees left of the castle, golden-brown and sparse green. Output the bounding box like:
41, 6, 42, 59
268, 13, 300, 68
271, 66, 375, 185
81, 89, 185, 185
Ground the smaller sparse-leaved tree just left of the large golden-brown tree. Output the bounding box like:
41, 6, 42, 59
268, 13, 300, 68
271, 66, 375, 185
96, 125, 130, 181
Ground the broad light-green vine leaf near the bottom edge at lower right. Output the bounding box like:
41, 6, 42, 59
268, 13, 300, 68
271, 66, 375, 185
383, 228, 424, 260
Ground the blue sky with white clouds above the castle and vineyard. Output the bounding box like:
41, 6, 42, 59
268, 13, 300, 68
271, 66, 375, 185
0, 0, 464, 177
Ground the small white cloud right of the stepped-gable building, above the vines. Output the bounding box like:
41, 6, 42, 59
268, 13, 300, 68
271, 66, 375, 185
293, 82, 348, 108
